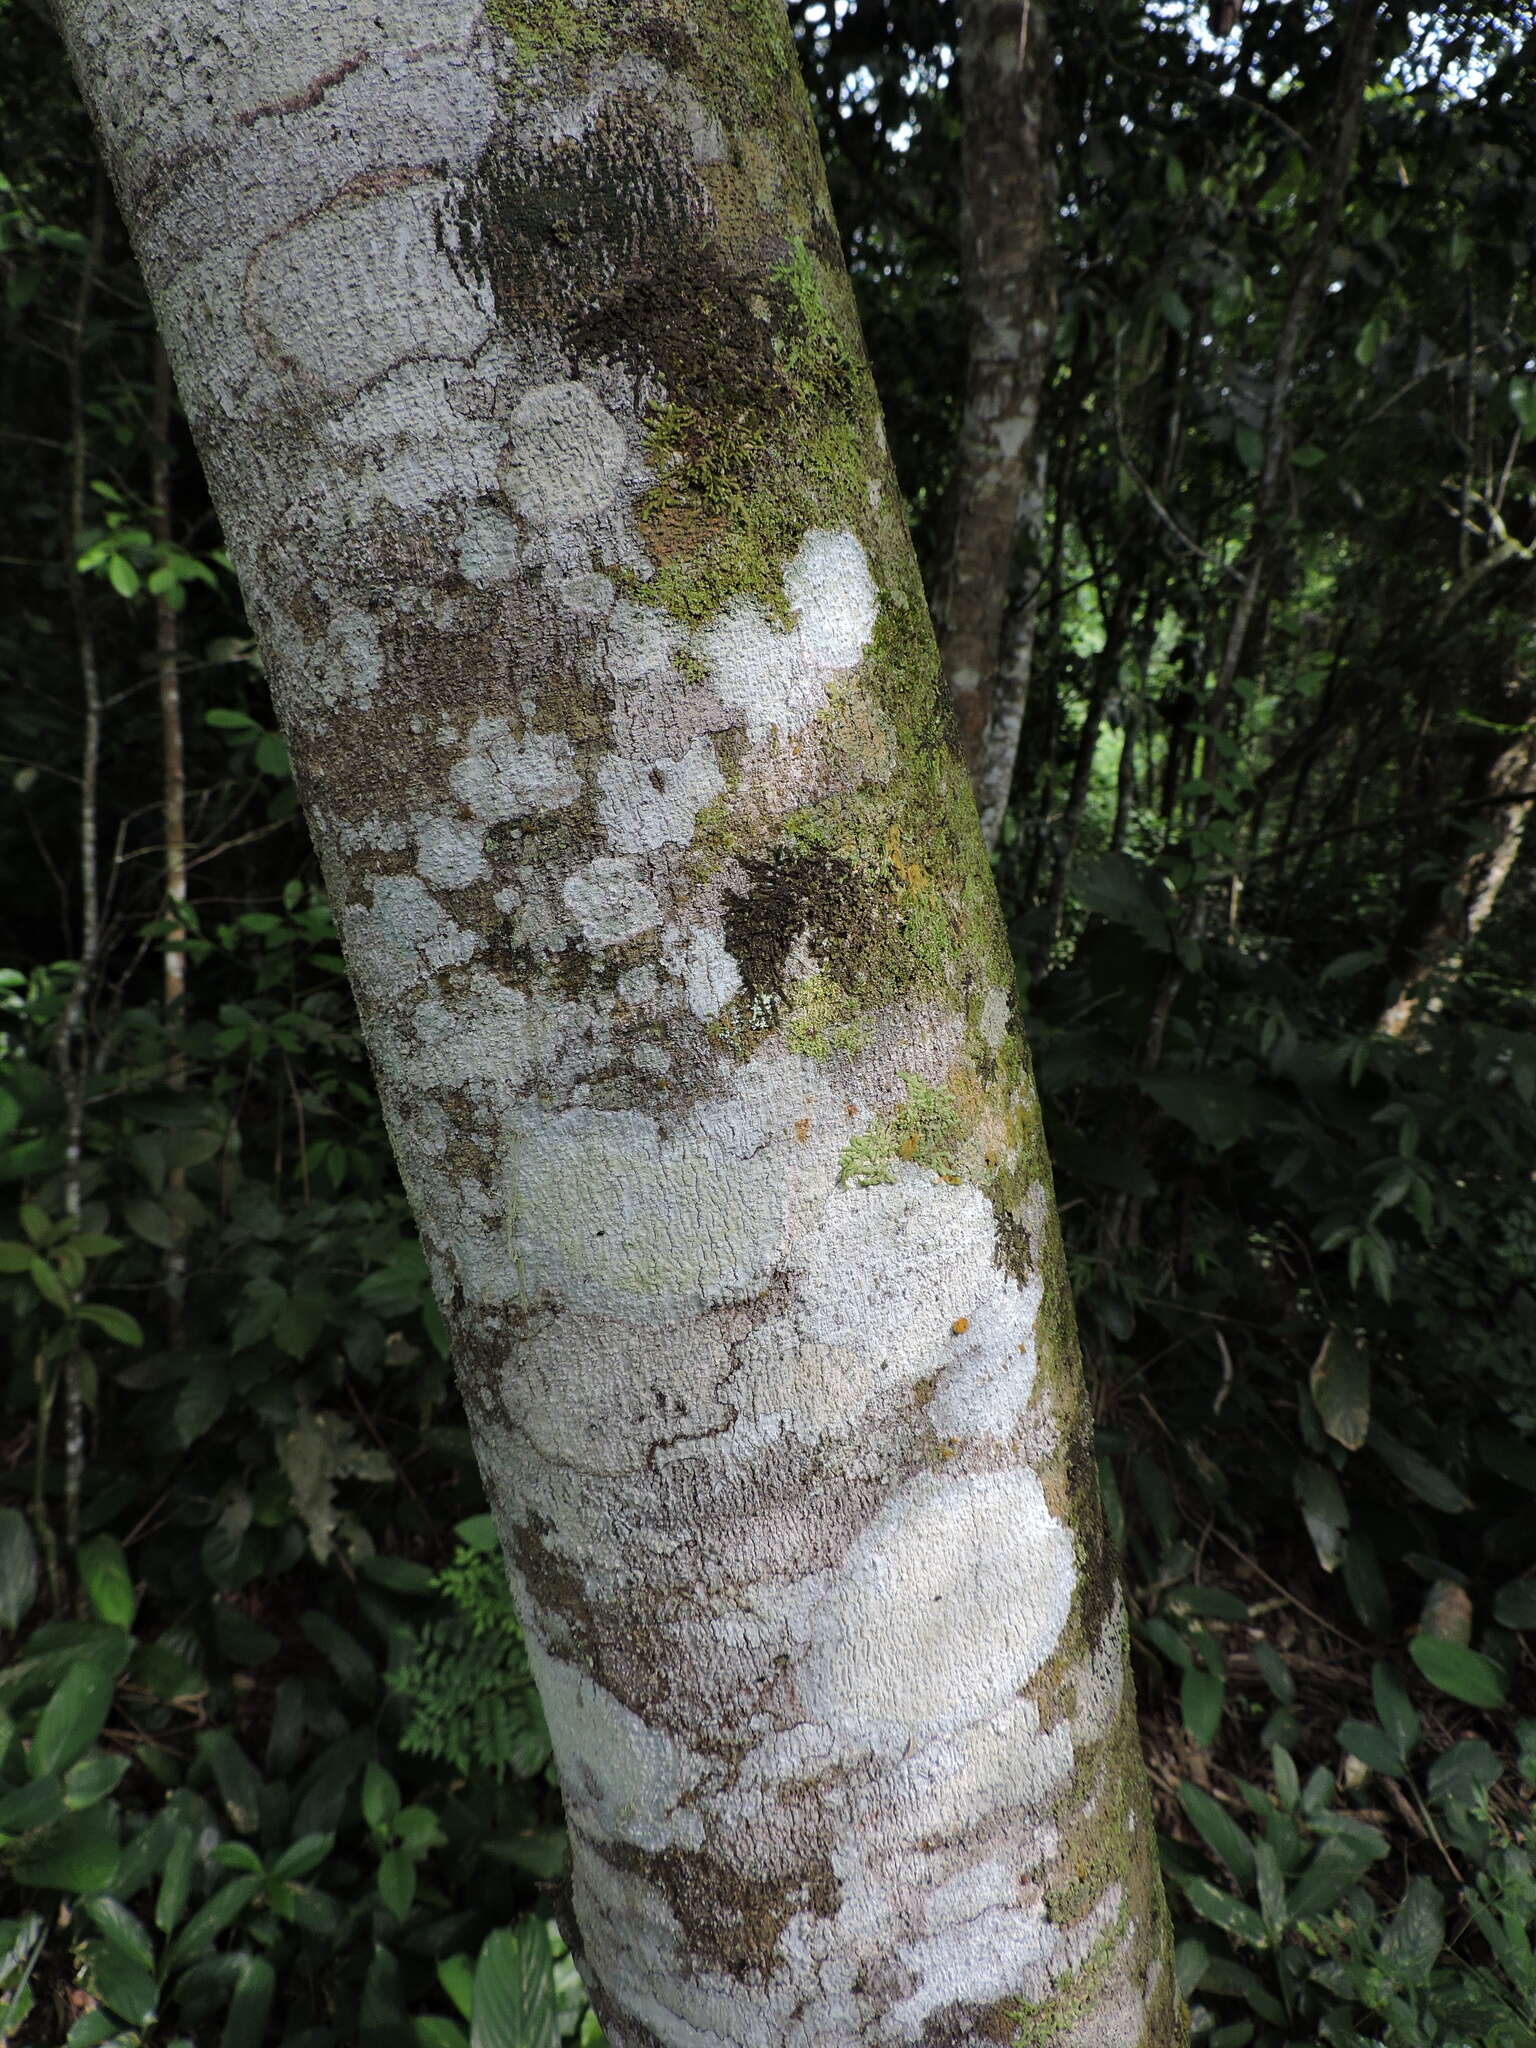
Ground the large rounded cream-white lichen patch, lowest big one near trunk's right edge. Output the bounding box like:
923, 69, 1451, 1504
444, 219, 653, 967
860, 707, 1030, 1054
799, 1470, 1075, 1729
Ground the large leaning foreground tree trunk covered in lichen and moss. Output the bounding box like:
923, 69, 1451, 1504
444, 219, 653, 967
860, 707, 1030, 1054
59, 0, 1180, 2048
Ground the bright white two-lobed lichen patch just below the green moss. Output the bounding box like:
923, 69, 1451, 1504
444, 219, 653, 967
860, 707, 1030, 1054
694, 530, 881, 741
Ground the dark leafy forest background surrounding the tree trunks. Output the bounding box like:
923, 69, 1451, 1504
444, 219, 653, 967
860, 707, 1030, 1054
0, 0, 1536, 2048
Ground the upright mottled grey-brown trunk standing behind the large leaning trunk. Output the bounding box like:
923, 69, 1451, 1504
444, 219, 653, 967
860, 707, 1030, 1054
934, 0, 1057, 846
